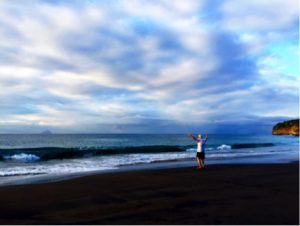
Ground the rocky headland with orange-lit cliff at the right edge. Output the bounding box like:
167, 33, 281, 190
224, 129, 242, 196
272, 119, 299, 136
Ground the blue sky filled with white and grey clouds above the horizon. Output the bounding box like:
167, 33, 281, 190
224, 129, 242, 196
0, 0, 299, 134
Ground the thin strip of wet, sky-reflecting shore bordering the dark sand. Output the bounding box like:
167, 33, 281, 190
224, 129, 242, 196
0, 154, 299, 187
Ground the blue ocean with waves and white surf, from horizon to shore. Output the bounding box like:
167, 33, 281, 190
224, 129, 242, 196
0, 134, 299, 185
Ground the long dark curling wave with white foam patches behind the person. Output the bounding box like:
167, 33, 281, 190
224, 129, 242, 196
0, 143, 274, 162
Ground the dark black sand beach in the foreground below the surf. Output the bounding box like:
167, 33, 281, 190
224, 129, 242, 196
0, 163, 299, 225
